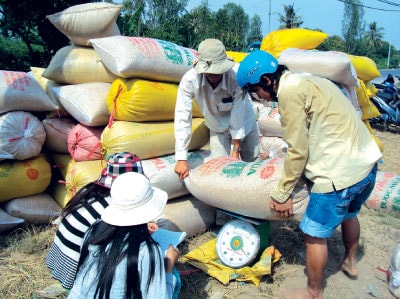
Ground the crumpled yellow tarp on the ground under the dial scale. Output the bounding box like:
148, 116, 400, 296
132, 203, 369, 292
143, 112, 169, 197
183, 238, 281, 286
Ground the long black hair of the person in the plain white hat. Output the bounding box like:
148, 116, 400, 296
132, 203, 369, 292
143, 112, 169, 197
78, 220, 164, 299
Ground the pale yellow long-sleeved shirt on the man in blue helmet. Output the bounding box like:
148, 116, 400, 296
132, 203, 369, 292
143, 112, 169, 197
271, 71, 382, 202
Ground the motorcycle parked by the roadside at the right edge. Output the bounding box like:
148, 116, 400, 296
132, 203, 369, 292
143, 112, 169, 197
370, 74, 400, 130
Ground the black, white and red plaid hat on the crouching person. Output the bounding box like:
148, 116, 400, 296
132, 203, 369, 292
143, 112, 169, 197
95, 152, 143, 188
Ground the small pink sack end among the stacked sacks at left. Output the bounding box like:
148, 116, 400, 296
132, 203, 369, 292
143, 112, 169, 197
68, 124, 104, 162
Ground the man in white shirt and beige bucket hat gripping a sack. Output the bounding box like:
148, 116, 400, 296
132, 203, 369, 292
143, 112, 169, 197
175, 39, 259, 180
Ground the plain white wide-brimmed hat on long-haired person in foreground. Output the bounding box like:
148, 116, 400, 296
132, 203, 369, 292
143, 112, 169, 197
101, 172, 168, 226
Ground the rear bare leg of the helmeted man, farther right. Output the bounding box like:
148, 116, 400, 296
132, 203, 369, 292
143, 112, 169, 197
340, 217, 360, 279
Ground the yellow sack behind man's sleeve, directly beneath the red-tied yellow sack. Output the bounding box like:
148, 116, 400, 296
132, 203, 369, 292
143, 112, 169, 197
101, 118, 210, 160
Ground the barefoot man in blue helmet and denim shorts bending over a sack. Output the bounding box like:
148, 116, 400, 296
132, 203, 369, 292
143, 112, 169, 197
237, 50, 382, 299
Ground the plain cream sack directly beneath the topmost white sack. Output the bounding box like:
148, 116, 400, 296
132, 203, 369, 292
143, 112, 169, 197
43, 45, 117, 84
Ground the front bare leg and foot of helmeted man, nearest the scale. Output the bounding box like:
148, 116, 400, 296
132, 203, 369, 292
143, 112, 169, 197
282, 235, 328, 299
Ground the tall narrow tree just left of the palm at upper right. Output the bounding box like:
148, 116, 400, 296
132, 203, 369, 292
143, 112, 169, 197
342, 0, 365, 55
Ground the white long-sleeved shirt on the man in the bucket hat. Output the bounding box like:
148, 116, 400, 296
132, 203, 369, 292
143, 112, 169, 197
174, 68, 256, 160
